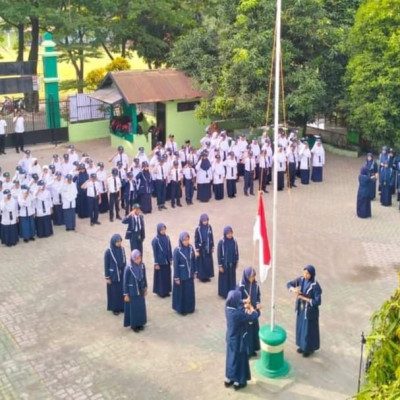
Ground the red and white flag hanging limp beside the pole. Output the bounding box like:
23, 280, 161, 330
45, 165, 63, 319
253, 194, 271, 282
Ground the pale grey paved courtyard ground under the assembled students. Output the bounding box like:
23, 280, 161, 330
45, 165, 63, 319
0, 140, 400, 400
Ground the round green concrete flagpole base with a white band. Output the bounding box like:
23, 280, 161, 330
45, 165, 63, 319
255, 325, 290, 378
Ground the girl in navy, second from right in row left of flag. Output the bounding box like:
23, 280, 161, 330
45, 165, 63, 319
194, 214, 214, 282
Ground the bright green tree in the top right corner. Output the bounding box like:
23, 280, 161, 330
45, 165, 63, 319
346, 0, 400, 146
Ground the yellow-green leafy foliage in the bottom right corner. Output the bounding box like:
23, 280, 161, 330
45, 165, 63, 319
356, 282, 400, 400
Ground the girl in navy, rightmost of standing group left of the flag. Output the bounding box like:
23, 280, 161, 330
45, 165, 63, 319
217, 226, 239, 299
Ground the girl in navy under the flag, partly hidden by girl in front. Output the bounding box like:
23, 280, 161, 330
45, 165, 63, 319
239, 267, 261, 357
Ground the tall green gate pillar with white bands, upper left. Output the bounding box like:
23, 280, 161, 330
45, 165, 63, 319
41, 32, 60, 129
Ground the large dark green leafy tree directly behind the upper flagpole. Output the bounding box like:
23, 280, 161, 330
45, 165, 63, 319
171, 0, 358, 130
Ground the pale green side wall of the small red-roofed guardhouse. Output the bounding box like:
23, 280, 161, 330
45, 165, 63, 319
165, 100, 210, 147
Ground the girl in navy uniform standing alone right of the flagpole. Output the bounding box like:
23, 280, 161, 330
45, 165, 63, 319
286, 265, 322, 357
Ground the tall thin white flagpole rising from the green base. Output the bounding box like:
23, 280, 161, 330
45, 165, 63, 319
270, 0, 282, 331
